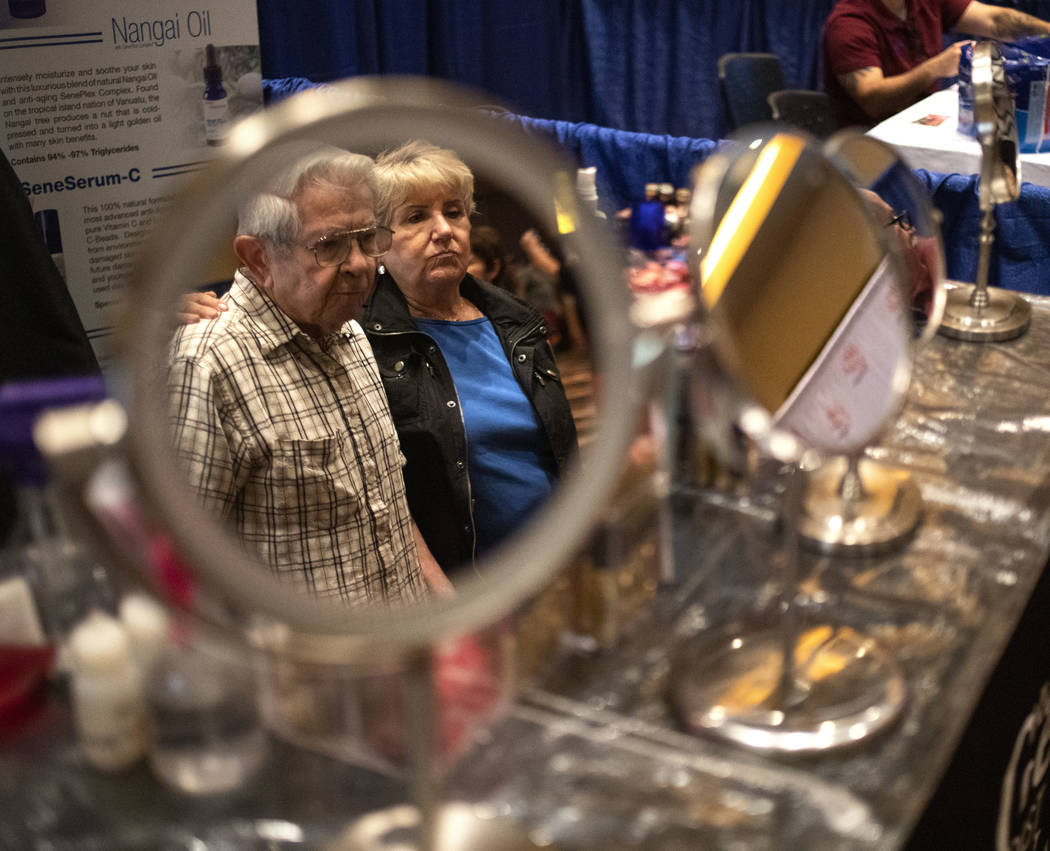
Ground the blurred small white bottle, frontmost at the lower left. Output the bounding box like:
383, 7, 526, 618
69, 611, 146, 771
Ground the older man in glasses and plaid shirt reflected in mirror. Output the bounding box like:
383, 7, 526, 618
169, 148, 447, 604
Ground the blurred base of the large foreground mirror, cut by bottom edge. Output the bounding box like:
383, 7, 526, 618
336, 802, 557, 851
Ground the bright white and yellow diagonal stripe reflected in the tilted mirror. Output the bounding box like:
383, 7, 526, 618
700, 133, 805, 307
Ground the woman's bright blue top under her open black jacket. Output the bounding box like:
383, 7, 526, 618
415, 316, 558, 555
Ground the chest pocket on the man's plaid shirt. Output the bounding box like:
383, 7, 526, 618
271, 434, 363, 531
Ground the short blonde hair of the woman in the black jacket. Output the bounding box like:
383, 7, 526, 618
376, 139, 474, 227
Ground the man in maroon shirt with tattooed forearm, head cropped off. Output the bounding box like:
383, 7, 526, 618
823, 0, 1050, 126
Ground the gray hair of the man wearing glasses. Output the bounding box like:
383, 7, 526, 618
237, 145, 377, 247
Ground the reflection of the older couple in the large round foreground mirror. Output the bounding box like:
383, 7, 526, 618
161, 140, 590, 605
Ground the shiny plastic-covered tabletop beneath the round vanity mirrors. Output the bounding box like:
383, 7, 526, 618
6, 297, 1050, 851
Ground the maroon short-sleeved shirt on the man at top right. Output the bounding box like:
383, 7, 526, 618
823, 0, 970, 127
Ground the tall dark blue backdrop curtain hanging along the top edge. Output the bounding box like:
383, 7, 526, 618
251, 0, 1050, 139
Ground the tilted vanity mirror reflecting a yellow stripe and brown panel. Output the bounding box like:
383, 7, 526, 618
693, 129, 911, 459
